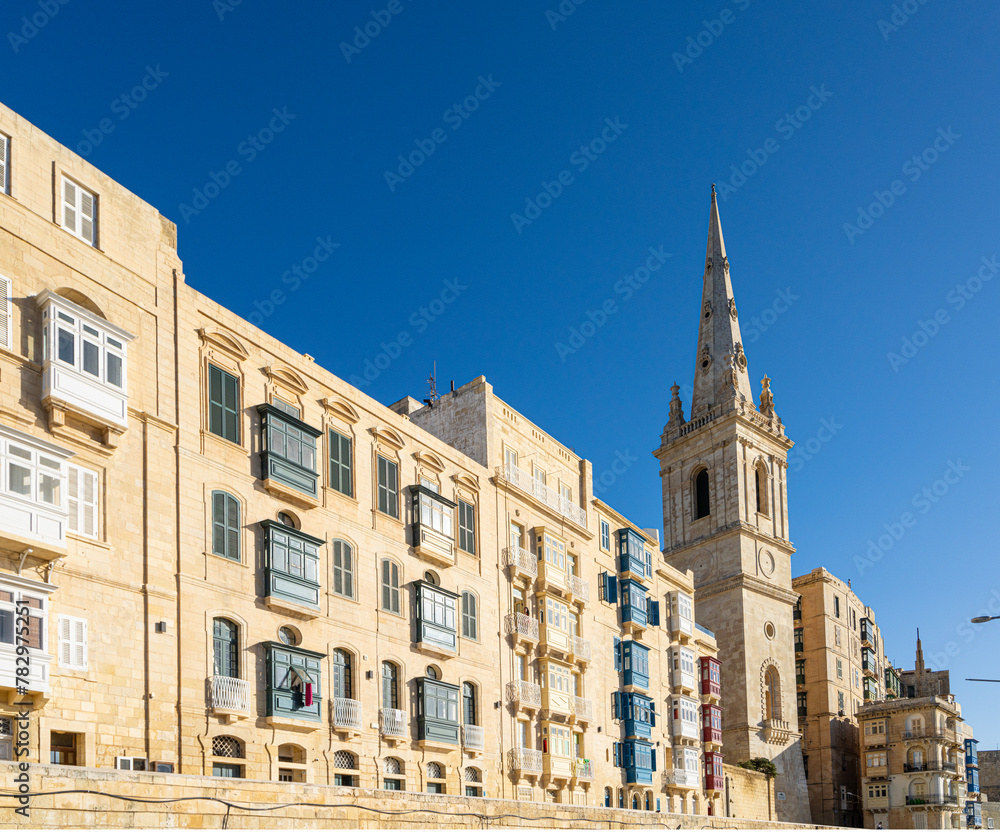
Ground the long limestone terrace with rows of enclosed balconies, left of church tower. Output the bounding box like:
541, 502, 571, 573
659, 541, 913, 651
0, 102, 740, 815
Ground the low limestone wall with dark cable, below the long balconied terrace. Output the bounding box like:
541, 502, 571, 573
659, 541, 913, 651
0, 765, 814, 829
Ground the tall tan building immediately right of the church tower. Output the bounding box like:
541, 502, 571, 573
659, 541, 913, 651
792, 568, 899, 826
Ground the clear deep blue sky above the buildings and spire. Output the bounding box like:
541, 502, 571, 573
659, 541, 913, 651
0, 0, 1000, 747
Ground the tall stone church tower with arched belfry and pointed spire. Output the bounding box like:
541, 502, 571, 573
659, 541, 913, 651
654, 190, 811, 823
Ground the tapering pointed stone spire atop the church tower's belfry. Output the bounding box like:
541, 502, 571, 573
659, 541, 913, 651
691, 185, 753, 419
